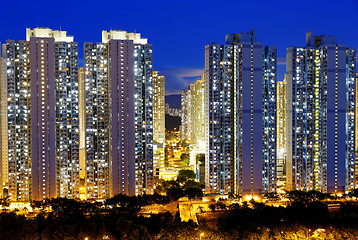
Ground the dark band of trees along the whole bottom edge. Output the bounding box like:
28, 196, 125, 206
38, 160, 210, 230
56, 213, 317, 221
0, 194, 358, 240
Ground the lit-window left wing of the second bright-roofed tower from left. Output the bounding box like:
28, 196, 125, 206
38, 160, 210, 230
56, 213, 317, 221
80, 43, 111, 199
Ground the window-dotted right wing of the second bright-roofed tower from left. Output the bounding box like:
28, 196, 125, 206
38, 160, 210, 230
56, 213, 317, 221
133, 43, 154, 195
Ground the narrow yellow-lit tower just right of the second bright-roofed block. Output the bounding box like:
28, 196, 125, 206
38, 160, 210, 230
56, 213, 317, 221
153, 71, 165, 179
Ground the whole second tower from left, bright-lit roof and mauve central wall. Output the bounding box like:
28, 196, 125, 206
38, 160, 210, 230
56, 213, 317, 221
84, 30, 153, 198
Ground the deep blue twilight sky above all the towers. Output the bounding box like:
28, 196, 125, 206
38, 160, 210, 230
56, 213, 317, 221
0, 0, 358, 94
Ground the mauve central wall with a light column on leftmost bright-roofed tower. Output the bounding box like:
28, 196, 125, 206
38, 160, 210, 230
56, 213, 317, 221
30, 37, 57, 200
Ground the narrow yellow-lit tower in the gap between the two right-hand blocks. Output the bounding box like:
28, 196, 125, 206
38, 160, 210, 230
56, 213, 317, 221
276, 77, 286, 189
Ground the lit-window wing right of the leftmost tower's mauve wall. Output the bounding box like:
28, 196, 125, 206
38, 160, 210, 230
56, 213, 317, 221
55, 42, 80, 198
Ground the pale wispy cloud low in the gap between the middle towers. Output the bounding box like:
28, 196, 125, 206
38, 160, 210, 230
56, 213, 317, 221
159, 67, 204, 95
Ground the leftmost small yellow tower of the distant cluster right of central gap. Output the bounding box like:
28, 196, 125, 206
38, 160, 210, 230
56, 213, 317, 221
180, 86, 191, 141
